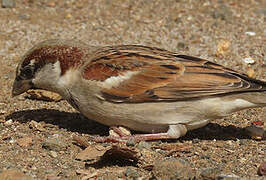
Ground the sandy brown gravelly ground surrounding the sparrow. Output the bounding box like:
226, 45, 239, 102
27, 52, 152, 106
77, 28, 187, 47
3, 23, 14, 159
0, 0, 266, 179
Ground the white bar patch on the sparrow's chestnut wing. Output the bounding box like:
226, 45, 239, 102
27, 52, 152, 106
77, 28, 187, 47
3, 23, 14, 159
102, 71, 139, 89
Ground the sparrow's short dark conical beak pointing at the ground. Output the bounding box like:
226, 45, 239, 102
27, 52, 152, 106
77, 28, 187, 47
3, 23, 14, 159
12, 79, 32, 97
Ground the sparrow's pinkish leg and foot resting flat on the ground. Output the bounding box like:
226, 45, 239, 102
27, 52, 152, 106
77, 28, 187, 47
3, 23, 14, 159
94, 124, 187, 143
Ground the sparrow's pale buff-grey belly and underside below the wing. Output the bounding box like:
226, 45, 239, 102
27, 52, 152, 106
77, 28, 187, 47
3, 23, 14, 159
68, 93, 256, 132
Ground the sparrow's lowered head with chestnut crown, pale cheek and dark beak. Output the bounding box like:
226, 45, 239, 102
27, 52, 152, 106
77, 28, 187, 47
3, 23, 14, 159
12, 39, 84, 96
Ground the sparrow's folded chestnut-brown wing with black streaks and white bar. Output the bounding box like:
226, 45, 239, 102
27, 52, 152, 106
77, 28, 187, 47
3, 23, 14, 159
83, 46, 265, 103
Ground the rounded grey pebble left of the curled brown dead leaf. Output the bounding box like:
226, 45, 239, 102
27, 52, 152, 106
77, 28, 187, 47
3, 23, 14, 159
42, 138, 67, 152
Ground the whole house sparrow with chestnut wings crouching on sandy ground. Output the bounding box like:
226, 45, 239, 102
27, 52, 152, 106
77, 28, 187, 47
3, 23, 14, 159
12, 40, 266, 142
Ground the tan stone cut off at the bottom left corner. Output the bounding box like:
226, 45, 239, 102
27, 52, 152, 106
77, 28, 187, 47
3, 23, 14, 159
0, 169, 33, 180
